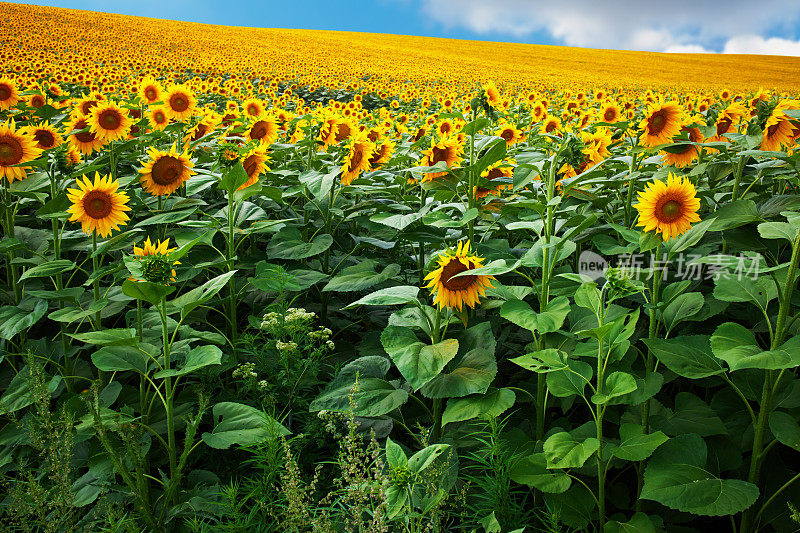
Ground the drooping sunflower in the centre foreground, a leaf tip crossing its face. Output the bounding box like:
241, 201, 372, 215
425, 241, 494, 311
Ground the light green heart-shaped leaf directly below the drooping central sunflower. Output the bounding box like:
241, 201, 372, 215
381, 326, 458, 391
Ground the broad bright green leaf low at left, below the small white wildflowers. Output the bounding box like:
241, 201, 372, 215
203, 402, 290, 450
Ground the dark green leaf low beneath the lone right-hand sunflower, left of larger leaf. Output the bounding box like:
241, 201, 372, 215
643, 335, 725, 379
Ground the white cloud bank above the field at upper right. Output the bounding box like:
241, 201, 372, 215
421, 0, 800, 55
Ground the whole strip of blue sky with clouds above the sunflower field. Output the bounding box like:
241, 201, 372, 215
15, 0, 800, 56
